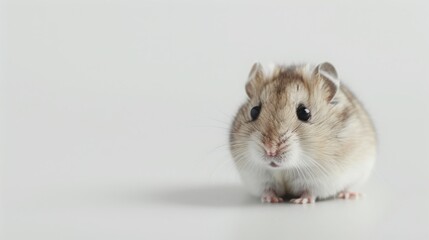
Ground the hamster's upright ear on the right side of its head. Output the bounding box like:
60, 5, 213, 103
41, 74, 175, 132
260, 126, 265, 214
313, 62, 340, 102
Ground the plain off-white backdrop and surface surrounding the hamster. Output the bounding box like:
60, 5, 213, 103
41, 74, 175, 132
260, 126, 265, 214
0, 0, 429, 240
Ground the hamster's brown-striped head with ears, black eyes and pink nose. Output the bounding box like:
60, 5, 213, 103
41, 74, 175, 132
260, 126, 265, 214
230, 63, 339, 169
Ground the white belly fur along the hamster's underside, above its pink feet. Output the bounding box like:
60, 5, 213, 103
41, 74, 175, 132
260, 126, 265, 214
239, 155, 374, 198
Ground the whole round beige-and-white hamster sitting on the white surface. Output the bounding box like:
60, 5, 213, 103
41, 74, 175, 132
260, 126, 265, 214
230, 62, 377, 204
